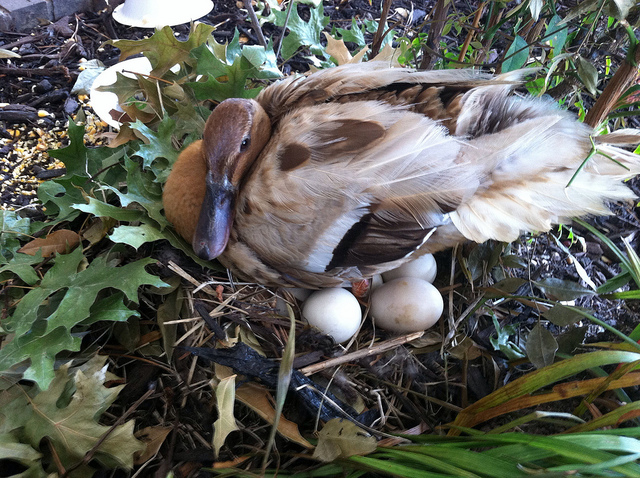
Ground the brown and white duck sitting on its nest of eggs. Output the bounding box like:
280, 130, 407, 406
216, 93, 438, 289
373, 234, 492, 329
163, 61, 640, 289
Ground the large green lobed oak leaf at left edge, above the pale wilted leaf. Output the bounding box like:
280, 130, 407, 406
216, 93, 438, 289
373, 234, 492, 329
0, 248, 165, 389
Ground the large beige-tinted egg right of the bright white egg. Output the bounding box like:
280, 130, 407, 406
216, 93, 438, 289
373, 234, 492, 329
371, 277, 444, 333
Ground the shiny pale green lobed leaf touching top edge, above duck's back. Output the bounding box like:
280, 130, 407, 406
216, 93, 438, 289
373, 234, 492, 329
273, 3, 329, 60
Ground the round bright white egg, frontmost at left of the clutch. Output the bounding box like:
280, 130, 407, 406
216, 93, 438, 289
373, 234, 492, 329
302, 288, 362, 344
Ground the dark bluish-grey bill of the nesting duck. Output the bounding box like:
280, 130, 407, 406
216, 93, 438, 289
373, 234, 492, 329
192, 171, 236, 260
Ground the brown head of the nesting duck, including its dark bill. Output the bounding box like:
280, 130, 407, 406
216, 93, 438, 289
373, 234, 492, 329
192, 98, 271, 260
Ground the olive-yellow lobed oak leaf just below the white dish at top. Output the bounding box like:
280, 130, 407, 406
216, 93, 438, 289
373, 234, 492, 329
107, 23, 215, 77
